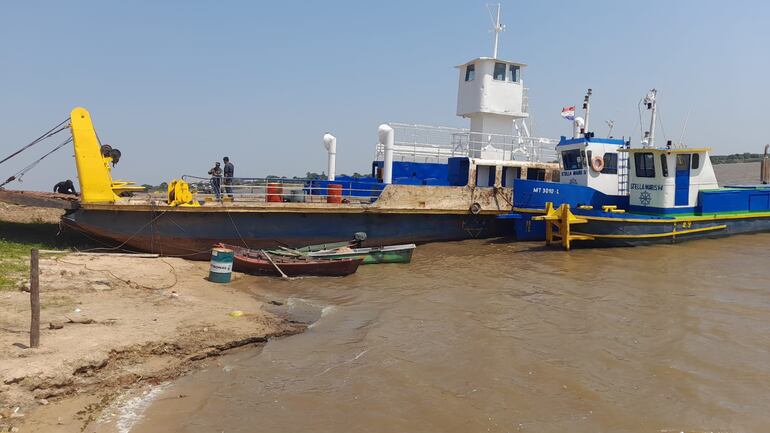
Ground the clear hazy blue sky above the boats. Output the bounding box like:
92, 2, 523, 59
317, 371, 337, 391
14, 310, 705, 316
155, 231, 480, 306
0, 0, 770, 189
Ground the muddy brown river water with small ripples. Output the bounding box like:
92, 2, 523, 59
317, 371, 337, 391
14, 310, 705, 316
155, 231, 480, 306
118, 164, 770, 433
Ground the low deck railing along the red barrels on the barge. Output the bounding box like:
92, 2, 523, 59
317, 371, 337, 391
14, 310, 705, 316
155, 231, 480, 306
182, 175, 385, 205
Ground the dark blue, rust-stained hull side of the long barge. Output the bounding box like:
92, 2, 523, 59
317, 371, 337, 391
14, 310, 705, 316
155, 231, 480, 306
62, 208, 513, 260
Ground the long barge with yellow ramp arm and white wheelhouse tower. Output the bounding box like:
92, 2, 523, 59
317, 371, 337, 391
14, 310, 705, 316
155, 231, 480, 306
0, 7, 559, 259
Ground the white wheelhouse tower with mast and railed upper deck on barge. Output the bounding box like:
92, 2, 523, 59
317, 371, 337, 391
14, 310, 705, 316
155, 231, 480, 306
376, 5, 557, 163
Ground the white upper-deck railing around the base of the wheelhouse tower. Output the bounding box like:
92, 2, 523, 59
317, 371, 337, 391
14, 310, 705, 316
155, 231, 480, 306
375, 122, 558, 164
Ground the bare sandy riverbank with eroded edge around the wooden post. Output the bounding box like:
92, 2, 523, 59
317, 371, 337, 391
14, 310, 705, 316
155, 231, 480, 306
0, 203, 307, 432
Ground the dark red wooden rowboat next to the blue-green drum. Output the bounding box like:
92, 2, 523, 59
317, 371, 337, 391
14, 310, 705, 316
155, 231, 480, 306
225, 244, 363, 277
